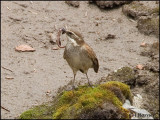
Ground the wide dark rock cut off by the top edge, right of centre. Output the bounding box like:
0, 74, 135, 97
94, 1, 131, 8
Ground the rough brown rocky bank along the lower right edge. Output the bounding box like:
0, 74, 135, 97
136, 41, 159, 119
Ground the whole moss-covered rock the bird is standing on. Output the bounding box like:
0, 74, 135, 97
19, 81, 132, 119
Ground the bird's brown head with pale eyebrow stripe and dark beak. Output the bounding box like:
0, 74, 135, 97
62, 28, 84, 46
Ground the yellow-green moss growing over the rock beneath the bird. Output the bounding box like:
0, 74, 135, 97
20, 81, 131, 119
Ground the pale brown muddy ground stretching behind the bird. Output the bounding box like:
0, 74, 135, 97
1, 1, 158, 119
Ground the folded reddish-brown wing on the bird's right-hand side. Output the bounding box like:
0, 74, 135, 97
83, 44, 99, 73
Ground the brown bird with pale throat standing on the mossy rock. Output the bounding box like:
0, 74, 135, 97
62, 29, 99, 88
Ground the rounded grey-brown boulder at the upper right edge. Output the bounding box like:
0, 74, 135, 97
137, 16, 159, 37
